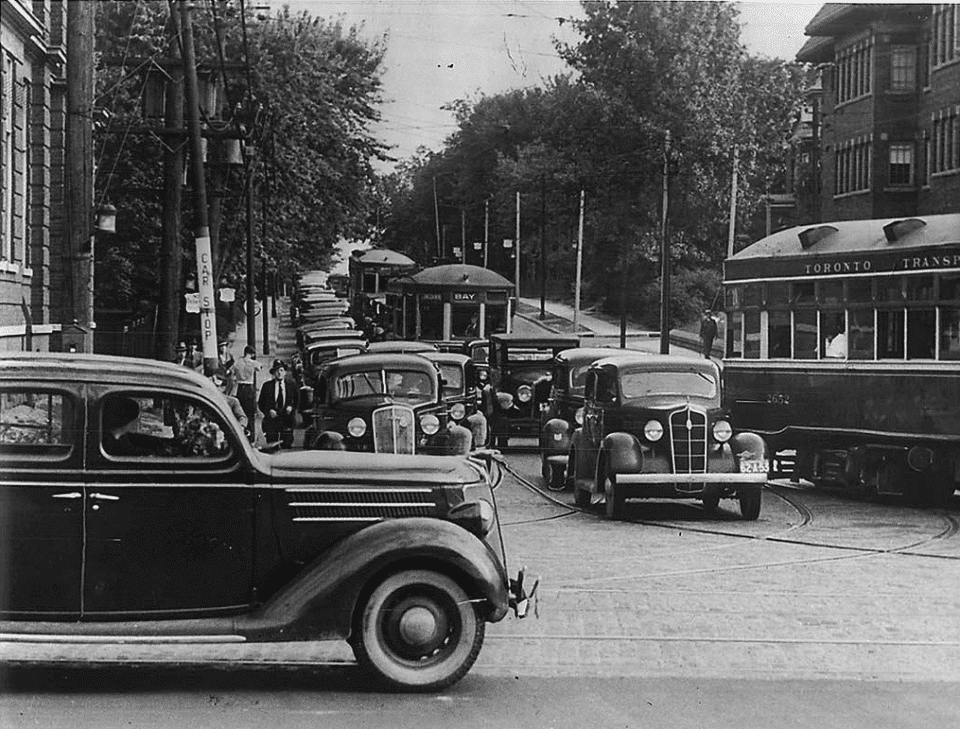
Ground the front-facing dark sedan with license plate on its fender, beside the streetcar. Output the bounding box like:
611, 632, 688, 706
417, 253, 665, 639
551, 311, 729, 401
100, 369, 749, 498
567, 353, 769, 520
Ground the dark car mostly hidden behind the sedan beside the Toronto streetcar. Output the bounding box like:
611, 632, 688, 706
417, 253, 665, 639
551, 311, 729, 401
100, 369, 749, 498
540, 347, 635, 491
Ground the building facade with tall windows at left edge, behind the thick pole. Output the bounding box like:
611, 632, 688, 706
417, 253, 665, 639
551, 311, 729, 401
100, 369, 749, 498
0, 0, 66, 352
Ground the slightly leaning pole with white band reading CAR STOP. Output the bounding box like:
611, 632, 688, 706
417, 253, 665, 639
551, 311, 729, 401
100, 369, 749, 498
179, 0, 217, 370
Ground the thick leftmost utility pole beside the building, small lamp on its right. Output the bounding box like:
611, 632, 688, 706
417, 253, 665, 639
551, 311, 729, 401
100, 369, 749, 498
64, 3, 97, 354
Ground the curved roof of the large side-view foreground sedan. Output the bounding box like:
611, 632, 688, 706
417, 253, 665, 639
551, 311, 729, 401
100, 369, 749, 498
0, 352, 213, 390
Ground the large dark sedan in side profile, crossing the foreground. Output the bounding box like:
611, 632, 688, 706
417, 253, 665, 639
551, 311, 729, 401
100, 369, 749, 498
0, 354, 522, 691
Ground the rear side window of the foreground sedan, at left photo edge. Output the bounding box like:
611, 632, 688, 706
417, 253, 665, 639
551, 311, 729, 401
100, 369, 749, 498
0, 389, 78, 457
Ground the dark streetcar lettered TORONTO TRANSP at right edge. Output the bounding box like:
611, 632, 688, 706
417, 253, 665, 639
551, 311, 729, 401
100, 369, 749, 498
723, 214, 960, 504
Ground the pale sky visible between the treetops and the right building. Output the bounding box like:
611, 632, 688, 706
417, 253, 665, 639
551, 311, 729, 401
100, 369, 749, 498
270, 0, 822, 166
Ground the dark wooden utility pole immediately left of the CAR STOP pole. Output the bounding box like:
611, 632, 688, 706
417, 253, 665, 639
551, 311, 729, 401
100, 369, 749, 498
156, 13, 185, 362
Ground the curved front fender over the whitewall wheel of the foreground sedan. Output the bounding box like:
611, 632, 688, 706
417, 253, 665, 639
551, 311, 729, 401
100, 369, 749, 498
237, 517, 509, 640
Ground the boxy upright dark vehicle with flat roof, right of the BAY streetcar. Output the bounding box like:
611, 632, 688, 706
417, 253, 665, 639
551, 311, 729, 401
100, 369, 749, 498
489, 334, 580, 447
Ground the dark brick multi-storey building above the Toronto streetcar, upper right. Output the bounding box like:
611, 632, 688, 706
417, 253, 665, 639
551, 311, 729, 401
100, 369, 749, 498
791, 3, 960, 223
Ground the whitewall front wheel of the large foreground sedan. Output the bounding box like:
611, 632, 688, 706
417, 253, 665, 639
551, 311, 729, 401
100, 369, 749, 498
353, 570, 485, 691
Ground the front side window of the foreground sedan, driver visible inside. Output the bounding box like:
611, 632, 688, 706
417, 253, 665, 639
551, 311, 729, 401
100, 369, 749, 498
100, 393, 232, 460
